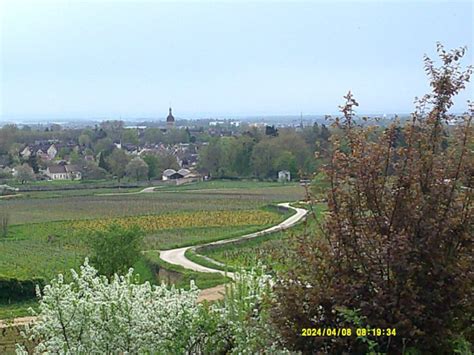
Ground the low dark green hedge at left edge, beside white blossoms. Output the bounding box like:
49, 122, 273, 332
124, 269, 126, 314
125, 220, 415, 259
0, 276, 45, 303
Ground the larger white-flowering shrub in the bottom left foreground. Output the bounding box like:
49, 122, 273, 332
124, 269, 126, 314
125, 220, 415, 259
17, 260, 201, 354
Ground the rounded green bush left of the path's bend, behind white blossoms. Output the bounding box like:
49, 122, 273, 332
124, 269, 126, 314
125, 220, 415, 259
89, 225, 142, 277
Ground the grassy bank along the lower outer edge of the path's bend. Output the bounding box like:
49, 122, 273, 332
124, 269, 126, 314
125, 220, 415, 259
144, 251, 231, 290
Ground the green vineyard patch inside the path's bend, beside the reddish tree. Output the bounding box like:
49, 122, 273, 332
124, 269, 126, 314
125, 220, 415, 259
199, 204, 326, 271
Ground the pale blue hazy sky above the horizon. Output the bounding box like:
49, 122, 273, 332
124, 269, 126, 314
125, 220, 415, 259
0, 0, 474, 120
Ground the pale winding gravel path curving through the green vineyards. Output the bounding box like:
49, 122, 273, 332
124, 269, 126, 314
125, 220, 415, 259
160, 202, 308, 279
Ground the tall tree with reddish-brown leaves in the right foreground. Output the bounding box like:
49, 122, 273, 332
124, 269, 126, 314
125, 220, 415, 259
273, 45, 474, 353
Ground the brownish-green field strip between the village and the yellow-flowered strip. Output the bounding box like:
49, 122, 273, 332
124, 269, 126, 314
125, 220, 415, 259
0, 182, 304, 224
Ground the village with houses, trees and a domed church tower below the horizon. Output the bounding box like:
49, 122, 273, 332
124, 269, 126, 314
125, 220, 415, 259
0, 108, 310, 194
